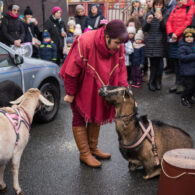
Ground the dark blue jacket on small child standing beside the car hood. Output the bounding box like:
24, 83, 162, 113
39, 41, 57, 62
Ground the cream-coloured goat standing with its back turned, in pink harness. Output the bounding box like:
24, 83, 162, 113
0, 88, 53, 194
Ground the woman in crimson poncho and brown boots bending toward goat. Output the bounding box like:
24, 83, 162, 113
60, 20, 129, 167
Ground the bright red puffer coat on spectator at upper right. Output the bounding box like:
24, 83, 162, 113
166, 0, 195, 40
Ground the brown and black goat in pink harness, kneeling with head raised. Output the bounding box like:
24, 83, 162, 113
99, 86, 193, 179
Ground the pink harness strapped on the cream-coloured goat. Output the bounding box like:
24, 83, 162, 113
0, 107, 31, 145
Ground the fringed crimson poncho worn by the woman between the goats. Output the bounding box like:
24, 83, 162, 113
60, 27, 128, 124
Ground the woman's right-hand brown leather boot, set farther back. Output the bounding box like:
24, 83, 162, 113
87, 123, 111, 159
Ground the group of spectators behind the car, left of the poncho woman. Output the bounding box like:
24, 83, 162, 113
1, 4, 104, 65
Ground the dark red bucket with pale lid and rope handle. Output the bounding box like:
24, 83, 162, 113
158, 148, 195, 195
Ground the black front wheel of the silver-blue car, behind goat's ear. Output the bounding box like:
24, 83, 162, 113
35, 83, 60, 122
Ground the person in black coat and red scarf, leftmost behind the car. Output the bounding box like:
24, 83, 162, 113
1, 4, 25, 47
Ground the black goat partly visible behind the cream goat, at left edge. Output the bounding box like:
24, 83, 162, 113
0, 80, 23, 107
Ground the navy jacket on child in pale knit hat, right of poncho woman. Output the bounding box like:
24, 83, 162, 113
132, 43, 145, 66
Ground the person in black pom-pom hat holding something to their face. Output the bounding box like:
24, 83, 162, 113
23, 6, 41, 57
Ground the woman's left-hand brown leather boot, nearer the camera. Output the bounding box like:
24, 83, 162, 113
72, 127, 102, 168
